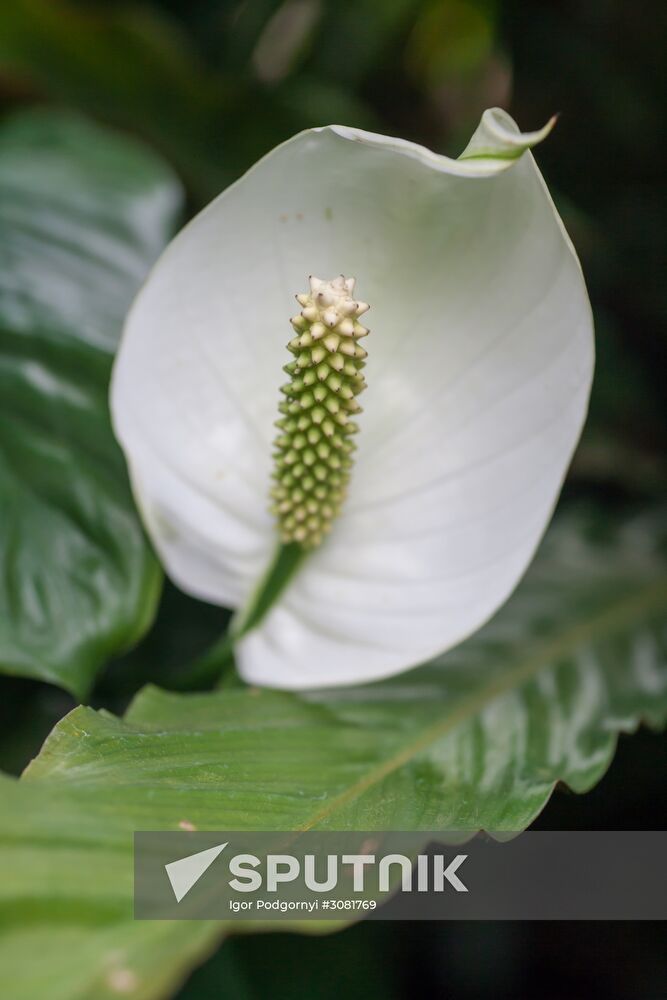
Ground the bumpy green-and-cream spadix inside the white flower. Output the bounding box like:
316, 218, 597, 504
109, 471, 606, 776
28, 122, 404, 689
271, 274, 369, 548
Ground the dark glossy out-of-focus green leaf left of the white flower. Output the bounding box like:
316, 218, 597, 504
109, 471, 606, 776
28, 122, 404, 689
0, 113, 180, 696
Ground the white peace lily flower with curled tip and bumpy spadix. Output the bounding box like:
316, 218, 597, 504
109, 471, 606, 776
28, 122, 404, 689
111, 110, 593, 688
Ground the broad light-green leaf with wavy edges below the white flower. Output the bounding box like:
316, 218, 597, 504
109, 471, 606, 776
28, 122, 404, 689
0, 518, 667, 1000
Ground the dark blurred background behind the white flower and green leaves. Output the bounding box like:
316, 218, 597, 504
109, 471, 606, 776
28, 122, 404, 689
0, 0, 667, 1000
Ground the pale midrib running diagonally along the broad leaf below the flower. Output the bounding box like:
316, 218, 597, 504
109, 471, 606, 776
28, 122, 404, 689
298, 579, 667, 831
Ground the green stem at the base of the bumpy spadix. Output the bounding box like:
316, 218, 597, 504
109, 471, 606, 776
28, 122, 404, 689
170, 542, 308, 691
